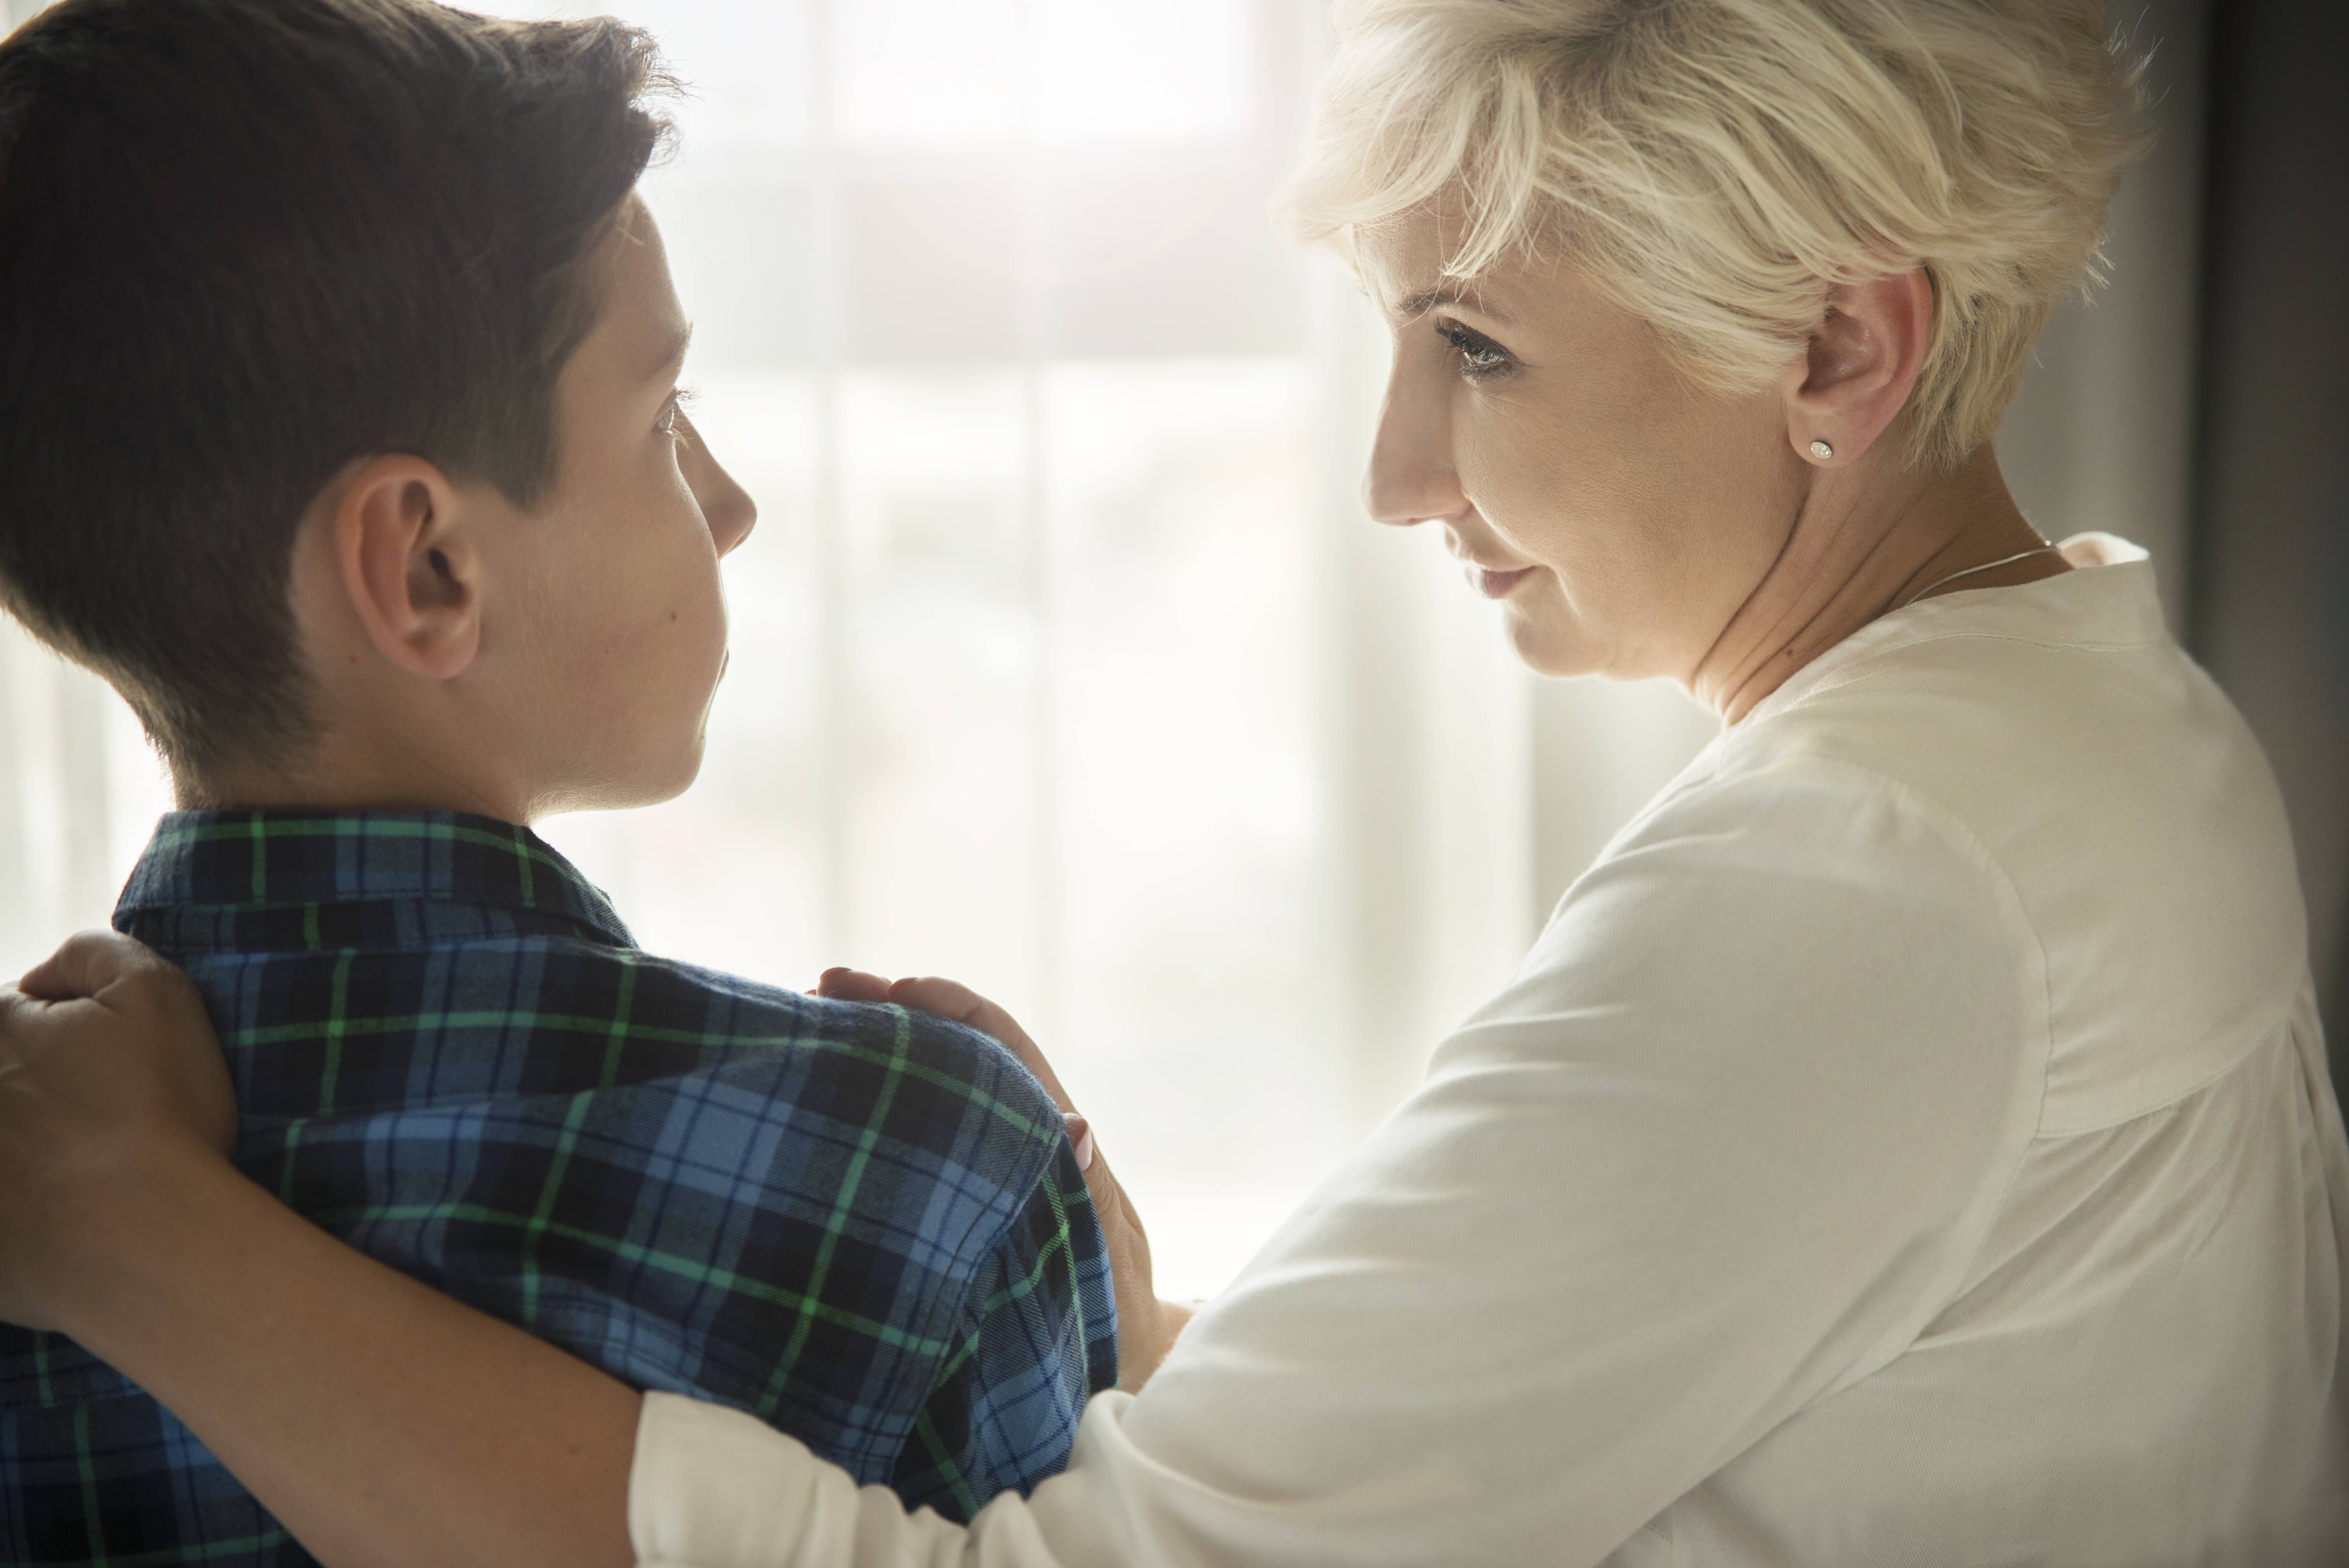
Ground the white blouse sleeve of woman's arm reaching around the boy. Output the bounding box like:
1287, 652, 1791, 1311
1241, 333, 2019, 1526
629, 758, 2048, 1568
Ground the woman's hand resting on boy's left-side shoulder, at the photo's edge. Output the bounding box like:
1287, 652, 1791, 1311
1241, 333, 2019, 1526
0, 932, 237, 1331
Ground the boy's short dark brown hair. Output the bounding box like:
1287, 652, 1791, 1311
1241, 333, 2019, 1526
0, 0, 665, 777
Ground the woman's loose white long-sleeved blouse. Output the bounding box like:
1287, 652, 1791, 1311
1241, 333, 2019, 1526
629, 535, 2349, 1568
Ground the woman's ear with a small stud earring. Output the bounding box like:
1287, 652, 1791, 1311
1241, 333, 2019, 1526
1783, 267, 1933, 467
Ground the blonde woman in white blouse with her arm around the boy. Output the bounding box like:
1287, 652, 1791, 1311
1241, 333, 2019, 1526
0, 0, 2349, 1568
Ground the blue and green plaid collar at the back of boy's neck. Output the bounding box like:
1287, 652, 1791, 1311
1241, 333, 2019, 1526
115, 812, 634, 946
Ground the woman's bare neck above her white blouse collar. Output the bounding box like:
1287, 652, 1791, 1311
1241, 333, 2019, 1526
1686, 441, 2072, 723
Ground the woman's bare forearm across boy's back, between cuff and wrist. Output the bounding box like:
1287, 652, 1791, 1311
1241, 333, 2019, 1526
54, 1157, 639, 1568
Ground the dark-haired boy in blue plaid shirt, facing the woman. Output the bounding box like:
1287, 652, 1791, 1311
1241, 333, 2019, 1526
0, 0, 1116, 1563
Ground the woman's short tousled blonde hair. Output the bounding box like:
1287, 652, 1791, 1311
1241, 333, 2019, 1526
1283, 0, 2142, 465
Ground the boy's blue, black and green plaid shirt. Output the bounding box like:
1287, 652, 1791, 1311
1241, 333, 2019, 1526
0, 812, 1116, 1568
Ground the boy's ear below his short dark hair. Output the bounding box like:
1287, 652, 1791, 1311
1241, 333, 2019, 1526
333, 453, 481, 681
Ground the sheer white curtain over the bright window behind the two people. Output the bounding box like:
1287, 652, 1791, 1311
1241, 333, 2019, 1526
0, 0, 2192, 1294
